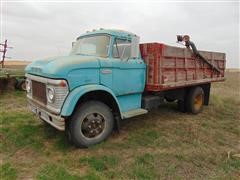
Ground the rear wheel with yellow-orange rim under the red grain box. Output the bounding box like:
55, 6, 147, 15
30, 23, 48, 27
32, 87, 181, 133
186, 86, 204, 114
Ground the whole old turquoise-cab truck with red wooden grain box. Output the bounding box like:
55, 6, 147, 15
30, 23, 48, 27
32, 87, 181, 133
25, 29, 225, 147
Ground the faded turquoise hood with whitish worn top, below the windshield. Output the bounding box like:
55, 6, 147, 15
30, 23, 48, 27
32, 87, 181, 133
25, 55, 100, 78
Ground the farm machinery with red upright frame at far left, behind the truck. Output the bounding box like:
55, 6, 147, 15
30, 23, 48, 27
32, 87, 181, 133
0, 40, 26, 94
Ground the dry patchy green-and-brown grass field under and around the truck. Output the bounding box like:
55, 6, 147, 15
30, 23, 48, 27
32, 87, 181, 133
0, 73, 240, 179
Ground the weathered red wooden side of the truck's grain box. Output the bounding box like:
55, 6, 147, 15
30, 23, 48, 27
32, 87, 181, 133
140, 43, 226, 91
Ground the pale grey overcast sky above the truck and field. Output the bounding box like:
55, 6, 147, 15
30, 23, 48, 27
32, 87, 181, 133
0, 0, 240, 68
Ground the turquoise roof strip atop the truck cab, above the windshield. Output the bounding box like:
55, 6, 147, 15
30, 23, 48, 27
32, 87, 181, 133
77, 28, 137, 39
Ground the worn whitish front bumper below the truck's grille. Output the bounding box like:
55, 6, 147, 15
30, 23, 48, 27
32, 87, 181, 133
28, 100, 65, 131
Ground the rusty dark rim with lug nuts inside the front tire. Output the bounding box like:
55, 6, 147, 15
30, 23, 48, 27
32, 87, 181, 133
81, 113, 105, 138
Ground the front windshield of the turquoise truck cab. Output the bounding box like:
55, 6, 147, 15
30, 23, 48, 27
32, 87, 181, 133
70, 35, 110, 57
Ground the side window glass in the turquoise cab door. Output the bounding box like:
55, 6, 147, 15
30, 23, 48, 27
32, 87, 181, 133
112, 39, 131, 59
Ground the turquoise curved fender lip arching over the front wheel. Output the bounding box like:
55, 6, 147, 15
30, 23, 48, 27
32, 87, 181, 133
61, 84, 121, 116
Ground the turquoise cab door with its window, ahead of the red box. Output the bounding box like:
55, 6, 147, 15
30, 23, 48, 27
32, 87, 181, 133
112, 38, 146, 96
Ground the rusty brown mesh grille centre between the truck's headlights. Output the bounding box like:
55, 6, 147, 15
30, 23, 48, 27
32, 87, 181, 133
32, 81, 47, 105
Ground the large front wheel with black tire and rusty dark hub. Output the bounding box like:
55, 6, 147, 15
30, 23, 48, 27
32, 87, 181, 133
68, 101, 113, 147
